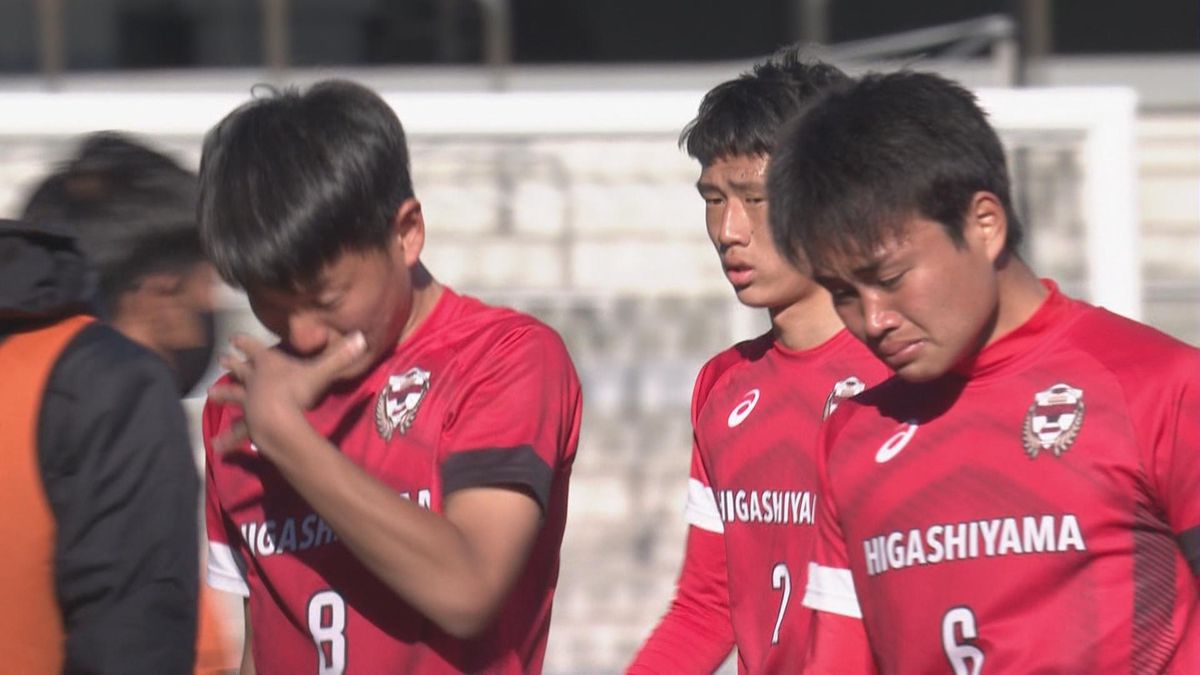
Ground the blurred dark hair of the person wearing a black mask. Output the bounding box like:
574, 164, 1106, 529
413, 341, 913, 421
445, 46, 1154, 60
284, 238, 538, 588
22, 132, 204, 315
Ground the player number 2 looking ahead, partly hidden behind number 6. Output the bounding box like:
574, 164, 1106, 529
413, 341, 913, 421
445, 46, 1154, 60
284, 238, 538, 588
630, 48, 887, 673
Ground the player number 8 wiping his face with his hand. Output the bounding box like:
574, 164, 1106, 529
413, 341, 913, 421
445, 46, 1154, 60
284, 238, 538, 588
199, 80, 581, 674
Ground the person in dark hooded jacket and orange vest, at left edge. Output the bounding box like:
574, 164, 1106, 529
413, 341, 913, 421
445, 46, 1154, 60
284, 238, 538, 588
0, 213, 199, 675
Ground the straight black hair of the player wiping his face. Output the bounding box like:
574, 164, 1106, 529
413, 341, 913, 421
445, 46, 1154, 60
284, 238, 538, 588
198, 79, 413, 291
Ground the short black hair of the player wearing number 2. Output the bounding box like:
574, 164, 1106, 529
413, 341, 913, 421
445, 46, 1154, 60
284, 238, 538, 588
679, 44, 848, 166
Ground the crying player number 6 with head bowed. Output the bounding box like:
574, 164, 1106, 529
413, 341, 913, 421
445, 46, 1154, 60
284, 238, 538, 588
768, 72, 1200, 675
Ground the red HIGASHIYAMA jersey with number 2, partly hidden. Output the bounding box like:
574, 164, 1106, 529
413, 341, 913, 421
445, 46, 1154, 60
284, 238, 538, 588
686, 330, 888, 673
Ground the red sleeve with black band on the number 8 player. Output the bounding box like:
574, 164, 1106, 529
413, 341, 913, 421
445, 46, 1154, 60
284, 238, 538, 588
439, 322, 582, 510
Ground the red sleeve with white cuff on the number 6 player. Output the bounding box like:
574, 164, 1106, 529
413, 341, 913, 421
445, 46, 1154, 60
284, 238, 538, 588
804, 416, 863, 619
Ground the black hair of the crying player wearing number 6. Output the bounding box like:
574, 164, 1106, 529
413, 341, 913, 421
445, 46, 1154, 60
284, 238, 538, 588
767, 71, 1022, 264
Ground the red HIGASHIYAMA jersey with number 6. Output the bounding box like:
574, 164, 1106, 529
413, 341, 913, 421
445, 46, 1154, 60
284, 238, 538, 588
804, 283, 1200, 675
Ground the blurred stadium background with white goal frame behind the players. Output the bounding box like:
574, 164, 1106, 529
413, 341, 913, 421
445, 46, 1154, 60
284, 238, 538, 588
0, 0, 1200, 673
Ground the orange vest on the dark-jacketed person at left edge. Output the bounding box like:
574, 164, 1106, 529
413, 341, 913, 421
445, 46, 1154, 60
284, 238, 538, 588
0, 316, 95, 675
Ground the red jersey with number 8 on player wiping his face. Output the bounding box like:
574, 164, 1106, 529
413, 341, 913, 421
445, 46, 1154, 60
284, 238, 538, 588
204, 289, 582, 675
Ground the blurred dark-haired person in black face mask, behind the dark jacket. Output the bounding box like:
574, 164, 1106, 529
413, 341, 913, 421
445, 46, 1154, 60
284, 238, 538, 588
23, 132, 238, 673
